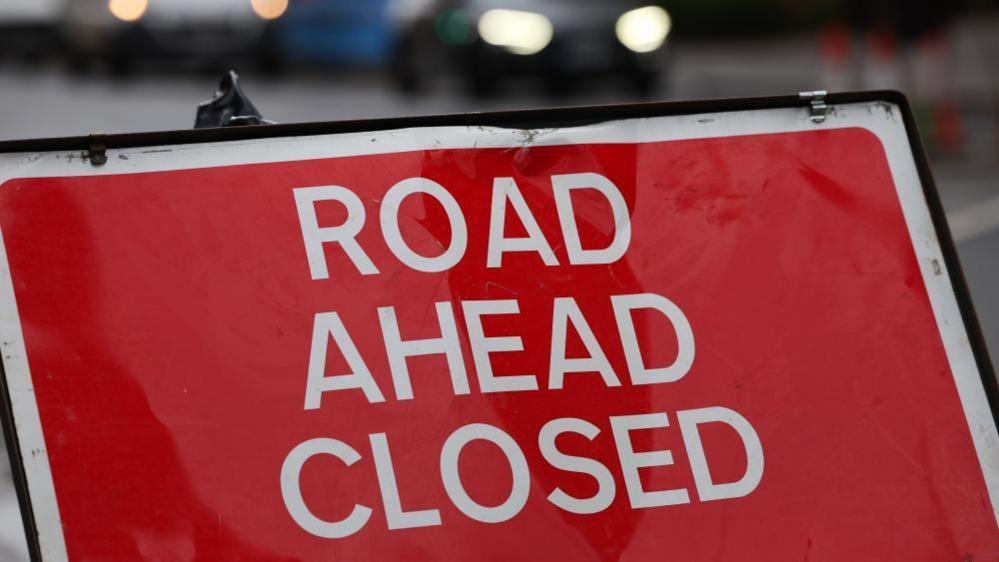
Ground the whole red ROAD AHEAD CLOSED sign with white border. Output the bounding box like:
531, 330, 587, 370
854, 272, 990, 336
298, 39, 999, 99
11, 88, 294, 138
0, 93, 999, 562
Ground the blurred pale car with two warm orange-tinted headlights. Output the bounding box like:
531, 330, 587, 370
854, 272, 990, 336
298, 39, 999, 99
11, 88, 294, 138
62, 0, 288, 73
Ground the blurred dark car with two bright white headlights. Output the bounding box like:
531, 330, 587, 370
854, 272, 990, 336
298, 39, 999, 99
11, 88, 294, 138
389, 0, 672, 95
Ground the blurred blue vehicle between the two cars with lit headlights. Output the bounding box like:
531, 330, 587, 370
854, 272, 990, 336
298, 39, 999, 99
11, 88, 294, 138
274, 0, 392, 66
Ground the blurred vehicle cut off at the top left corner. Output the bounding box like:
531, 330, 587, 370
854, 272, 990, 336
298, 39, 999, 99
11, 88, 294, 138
0, 0, 64, 58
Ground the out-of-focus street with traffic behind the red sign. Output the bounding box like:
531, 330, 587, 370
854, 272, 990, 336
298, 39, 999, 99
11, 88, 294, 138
0, 0, 999, 562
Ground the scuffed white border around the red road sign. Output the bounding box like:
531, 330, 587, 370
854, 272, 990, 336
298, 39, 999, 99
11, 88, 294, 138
0, 101, 999, 562
